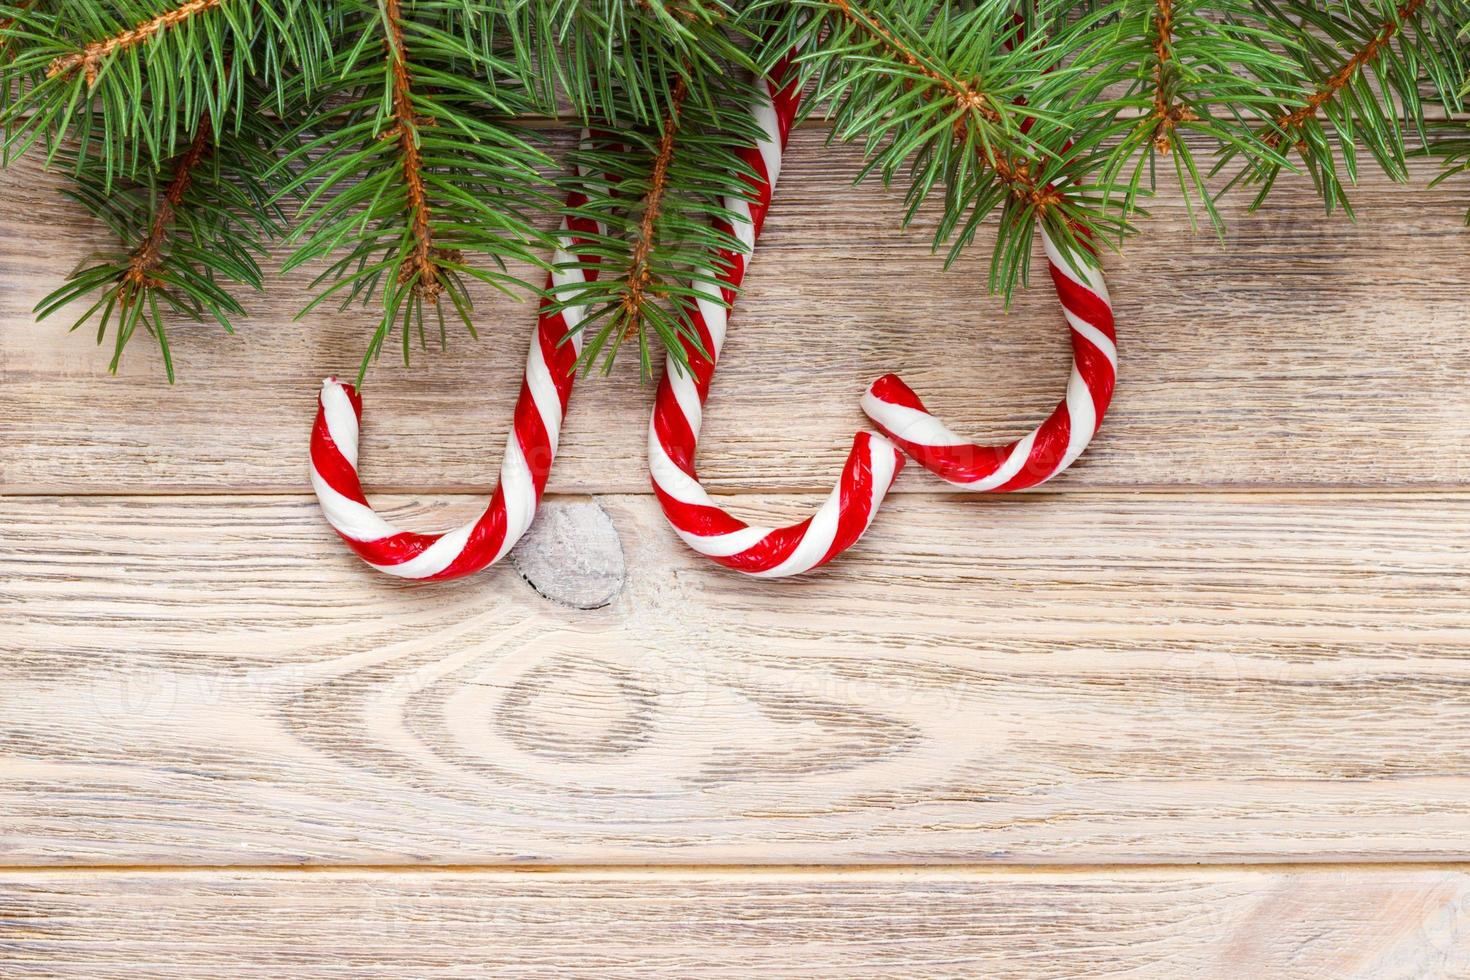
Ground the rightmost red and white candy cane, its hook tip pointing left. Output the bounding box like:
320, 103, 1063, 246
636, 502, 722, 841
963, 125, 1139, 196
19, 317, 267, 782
863, 231, 1117, 492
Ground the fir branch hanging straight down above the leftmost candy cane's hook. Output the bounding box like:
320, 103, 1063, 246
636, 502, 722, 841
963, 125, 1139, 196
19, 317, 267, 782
281, 0, 553, 381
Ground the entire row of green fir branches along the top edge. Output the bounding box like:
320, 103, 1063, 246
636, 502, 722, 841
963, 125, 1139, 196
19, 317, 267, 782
0, 0, 1470, 376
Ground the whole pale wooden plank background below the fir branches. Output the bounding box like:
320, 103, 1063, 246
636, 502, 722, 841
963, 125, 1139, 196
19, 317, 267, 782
0, 128, 1470, 977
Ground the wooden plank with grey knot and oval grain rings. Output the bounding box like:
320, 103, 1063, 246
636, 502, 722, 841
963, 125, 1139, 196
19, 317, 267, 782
0, 494, 1470, 865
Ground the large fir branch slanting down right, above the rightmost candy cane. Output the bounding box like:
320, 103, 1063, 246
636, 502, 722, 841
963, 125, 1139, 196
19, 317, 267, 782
753, 0, 1126, 295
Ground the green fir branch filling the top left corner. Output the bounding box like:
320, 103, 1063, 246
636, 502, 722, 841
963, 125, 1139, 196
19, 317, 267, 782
0, 0, 324, 179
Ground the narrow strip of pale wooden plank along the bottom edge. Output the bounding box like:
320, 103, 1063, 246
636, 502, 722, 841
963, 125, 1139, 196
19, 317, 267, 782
0, 868, 1470, 980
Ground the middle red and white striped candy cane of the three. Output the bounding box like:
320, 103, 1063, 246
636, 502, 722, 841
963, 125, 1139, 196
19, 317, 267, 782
648, 60, 904, 577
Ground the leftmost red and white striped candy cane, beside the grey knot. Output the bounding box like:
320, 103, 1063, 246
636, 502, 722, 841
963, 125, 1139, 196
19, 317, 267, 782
312, 134, 604, 579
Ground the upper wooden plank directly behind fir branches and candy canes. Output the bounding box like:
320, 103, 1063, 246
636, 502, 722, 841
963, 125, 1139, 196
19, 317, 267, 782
0, 128, 1470, 494
